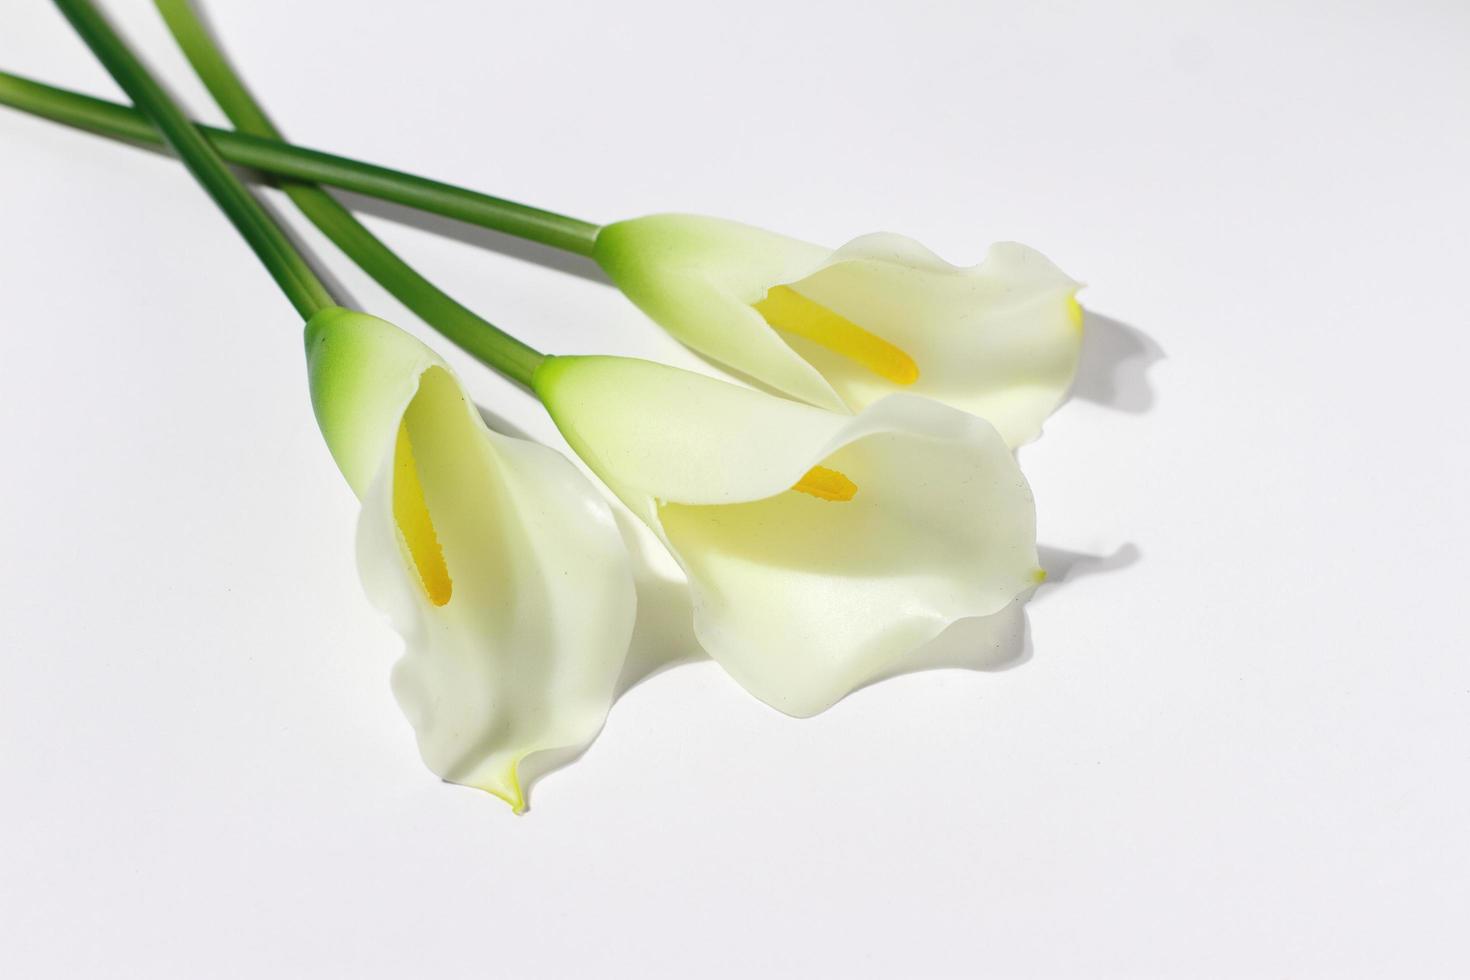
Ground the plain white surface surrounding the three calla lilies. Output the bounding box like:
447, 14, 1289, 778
0, 0, 1470, 977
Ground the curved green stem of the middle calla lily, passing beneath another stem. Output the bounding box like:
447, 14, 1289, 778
156, 0, 544, 388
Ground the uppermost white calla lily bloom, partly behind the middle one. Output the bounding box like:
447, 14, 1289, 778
592, 215, 1082, 447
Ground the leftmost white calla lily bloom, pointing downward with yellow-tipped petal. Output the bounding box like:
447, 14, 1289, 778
306, 307, 635, 813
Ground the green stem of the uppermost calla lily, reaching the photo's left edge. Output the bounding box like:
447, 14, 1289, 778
0, 72, 598, 256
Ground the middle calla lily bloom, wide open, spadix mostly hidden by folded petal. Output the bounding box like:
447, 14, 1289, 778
534, 357, 1039, 716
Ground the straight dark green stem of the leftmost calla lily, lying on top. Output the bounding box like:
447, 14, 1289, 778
56, 0, 335, 319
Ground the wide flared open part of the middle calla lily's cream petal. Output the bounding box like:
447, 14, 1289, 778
659, 395, 1039, 716
